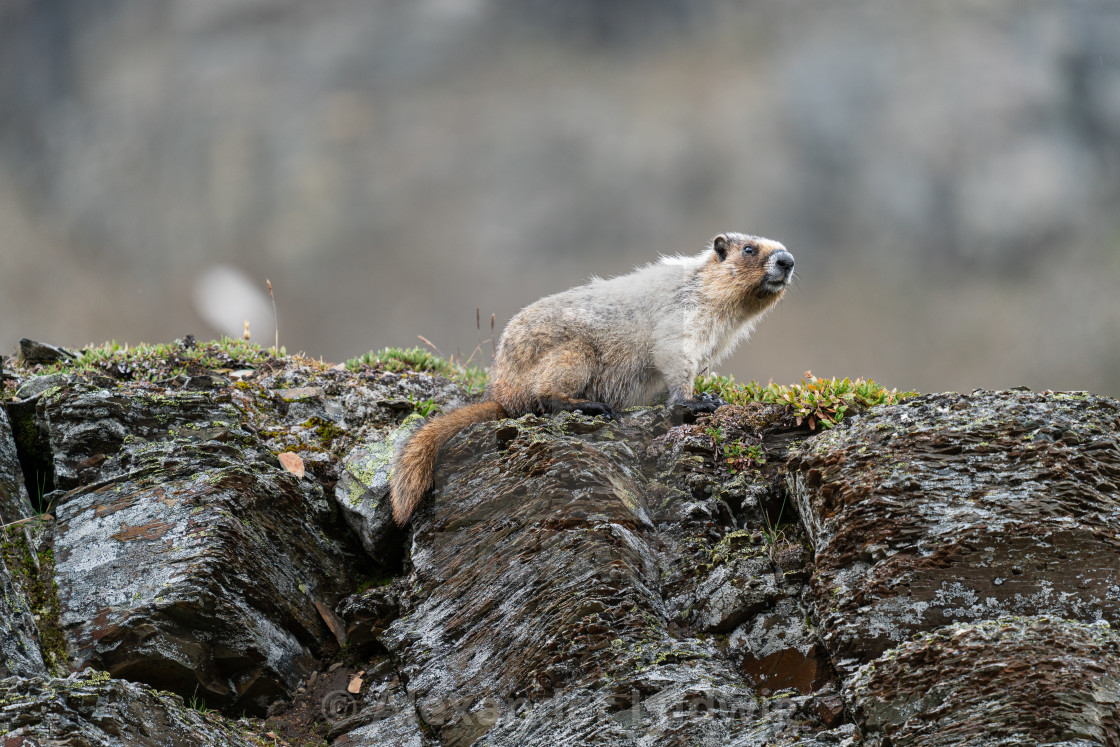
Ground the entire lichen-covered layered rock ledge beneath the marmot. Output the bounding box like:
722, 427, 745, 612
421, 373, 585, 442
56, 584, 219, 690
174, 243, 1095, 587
0, 342, 1120, 747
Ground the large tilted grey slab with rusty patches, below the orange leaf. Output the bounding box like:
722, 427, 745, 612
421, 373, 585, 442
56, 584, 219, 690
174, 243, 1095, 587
55, 442, 354, 710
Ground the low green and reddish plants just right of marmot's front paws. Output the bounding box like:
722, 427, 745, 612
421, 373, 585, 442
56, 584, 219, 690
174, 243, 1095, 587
696, 371, 917, 430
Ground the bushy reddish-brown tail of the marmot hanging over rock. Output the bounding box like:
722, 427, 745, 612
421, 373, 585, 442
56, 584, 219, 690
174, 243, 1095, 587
389, 402, 506, 526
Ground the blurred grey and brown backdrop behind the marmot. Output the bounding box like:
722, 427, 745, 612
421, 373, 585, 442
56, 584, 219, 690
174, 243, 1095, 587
0, 0, 1120, 395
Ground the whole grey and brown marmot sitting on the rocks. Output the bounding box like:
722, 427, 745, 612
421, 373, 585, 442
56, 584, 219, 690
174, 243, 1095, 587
390, 233, 793, 524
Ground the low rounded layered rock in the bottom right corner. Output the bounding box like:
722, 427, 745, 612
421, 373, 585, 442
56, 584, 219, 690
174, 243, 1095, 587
846, 617, 1120, 747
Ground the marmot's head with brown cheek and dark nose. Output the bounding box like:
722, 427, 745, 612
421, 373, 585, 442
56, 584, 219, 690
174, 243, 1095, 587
711, 233, 793, 307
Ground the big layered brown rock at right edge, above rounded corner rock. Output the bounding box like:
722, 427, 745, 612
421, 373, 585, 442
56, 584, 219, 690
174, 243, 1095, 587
791, 391, 1120, 676
